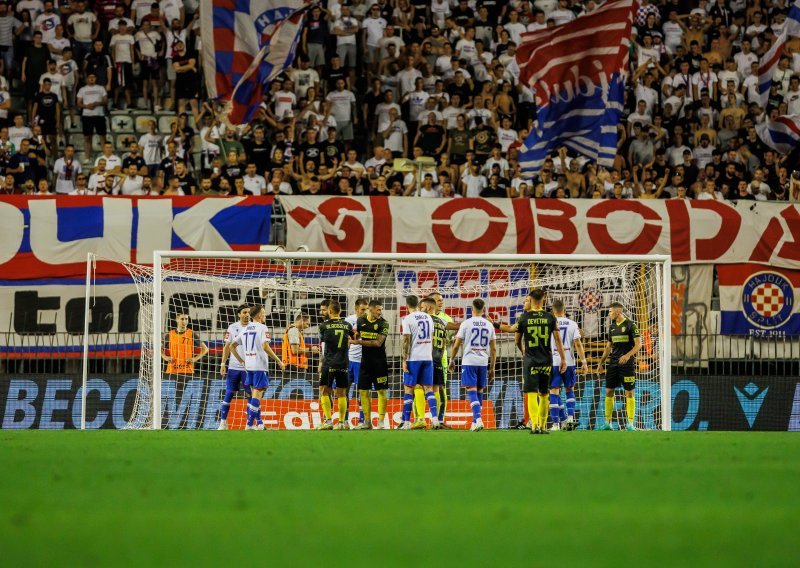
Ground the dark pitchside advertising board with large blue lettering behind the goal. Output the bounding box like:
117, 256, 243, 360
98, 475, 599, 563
0, 375, 800, 431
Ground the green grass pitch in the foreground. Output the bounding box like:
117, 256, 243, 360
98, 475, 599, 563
0, 431, 800, 568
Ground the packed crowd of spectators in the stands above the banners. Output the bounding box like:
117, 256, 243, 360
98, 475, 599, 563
0, 0, 800, 201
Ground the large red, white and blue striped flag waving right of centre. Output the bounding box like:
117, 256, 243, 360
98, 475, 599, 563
517, 0, 637, 177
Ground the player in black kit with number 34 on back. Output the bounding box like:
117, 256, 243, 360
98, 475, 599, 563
514, 288, 567, 434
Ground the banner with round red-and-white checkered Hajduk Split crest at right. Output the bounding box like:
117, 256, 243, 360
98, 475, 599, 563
717, 264, 800, 337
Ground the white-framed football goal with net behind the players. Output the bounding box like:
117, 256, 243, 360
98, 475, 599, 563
84, 252, 670, 430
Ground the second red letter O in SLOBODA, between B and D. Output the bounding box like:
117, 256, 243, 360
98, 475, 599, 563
586, 199, 662, 254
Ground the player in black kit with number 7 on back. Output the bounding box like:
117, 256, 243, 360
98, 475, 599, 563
318, 301, 354, 430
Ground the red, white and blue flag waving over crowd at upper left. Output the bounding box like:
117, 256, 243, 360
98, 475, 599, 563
200, 0, 310, 124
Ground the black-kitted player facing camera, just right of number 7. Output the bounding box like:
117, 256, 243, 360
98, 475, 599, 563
353, 300, 389, 430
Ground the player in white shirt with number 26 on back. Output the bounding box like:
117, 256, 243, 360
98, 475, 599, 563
449, 298, 497, 432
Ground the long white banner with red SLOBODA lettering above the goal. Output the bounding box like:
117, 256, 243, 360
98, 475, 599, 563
281, 196, 800, 268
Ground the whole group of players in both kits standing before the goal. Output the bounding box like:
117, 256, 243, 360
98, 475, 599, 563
219, 288, 642, 434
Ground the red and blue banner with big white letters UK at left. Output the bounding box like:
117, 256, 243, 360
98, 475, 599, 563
0, 196, 272, 279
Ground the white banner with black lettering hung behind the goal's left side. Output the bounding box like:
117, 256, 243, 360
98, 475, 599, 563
0, 265, 361, 358
